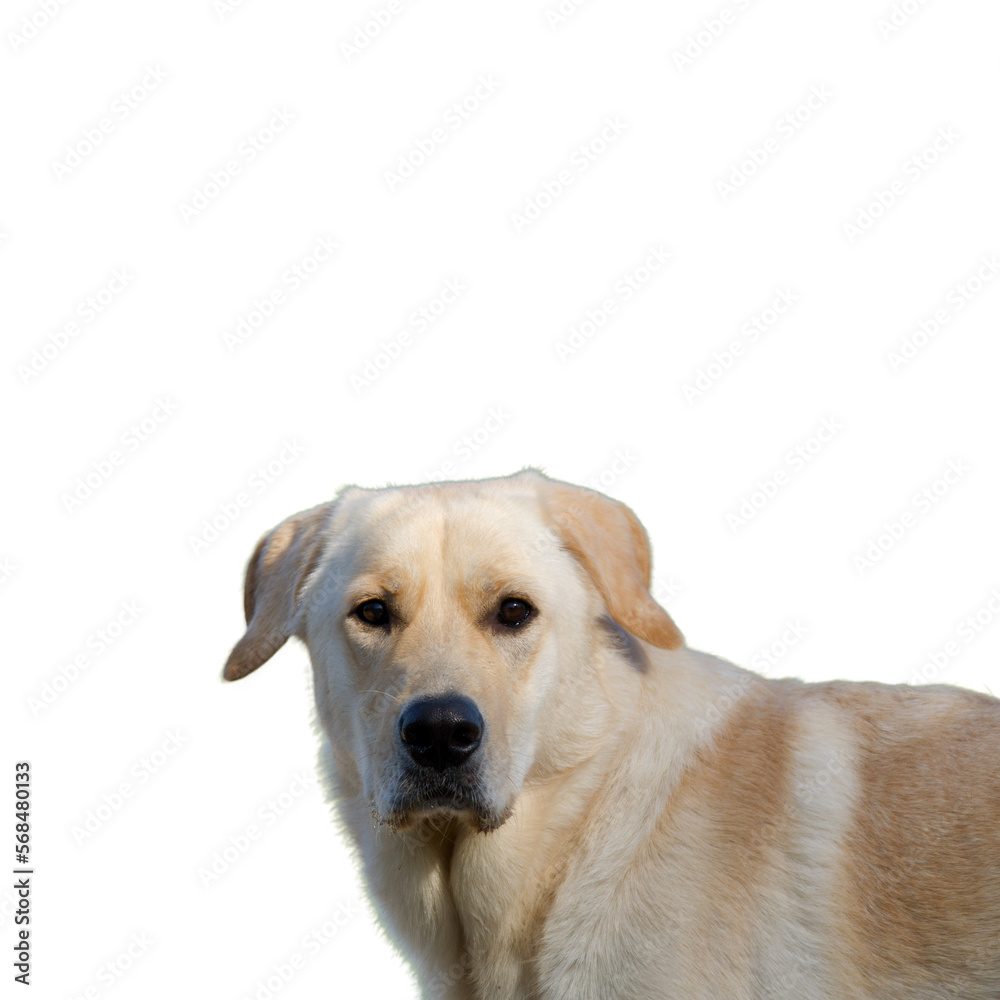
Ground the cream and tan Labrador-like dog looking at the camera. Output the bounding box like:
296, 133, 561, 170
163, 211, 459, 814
223, 469, 1000, 1000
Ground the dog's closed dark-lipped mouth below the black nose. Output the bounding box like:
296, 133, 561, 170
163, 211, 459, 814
371, 772, 511, 833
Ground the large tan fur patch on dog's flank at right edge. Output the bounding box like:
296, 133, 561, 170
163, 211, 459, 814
837, 684, 1000, 998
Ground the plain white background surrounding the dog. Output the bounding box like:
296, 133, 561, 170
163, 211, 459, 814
0, 0, 1000, 1000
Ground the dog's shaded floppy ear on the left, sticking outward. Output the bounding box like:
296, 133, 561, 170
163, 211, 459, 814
222, 501, 333, 681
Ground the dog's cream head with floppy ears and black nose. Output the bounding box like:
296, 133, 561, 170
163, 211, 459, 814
223, 470, 683, 831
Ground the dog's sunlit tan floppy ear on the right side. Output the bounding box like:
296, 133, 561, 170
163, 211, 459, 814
541, 480, 684, 649
